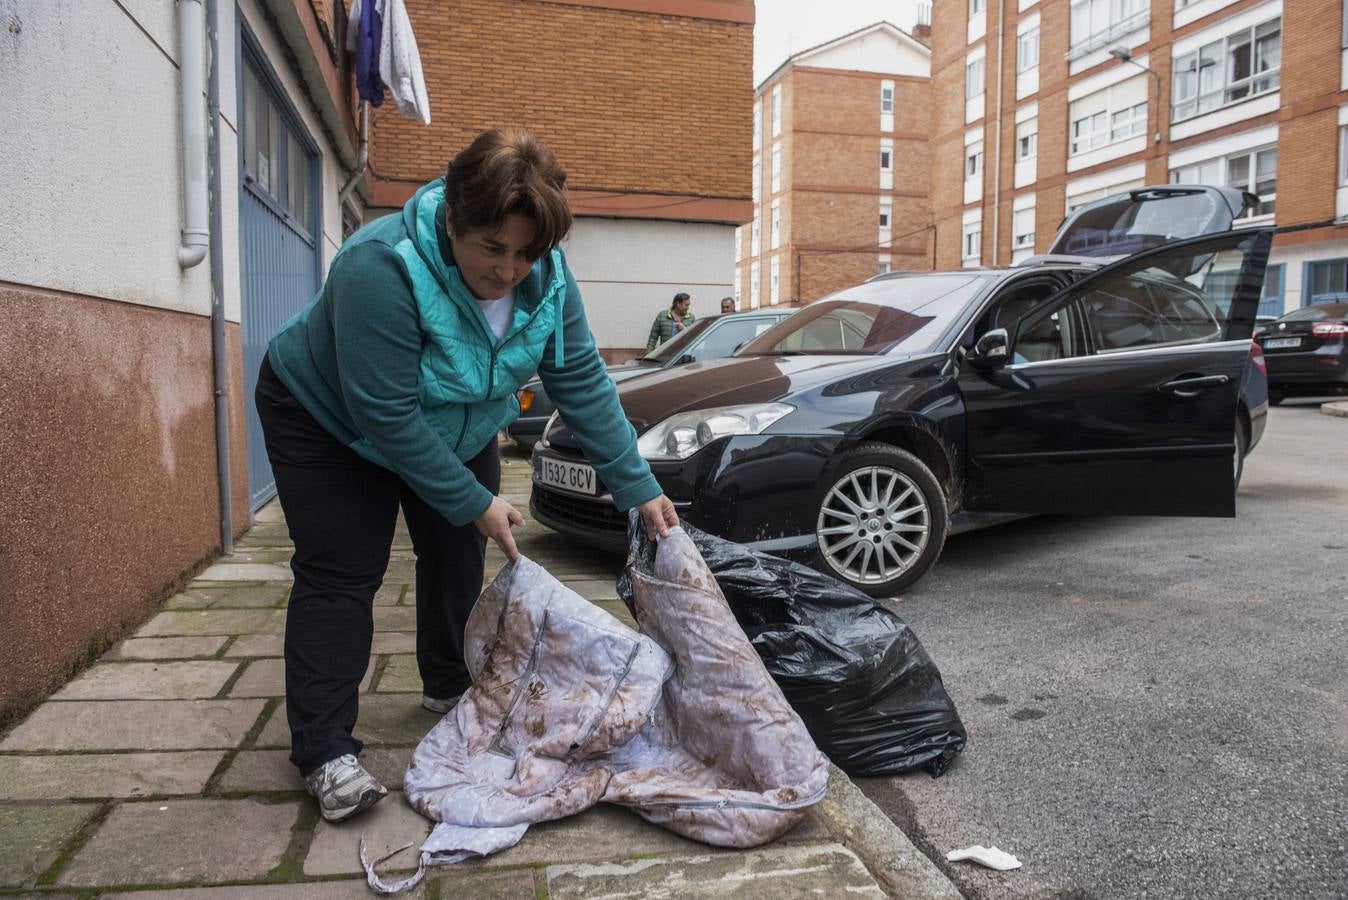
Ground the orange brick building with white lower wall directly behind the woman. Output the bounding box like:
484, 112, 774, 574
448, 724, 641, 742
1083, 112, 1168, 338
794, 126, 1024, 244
365, 0, 754, 358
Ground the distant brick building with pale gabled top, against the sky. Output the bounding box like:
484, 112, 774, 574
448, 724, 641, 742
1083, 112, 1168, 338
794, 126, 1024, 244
735, 22, 931, 309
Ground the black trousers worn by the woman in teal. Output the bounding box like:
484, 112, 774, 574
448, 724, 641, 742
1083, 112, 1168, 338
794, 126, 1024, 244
256, 360, 500, 775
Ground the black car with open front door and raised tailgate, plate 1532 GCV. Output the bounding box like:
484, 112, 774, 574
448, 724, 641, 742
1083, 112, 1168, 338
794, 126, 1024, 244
530, 186, 1273, 596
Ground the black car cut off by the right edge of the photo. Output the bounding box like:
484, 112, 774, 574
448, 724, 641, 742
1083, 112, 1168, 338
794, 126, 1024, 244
1255, 303, 1348, 406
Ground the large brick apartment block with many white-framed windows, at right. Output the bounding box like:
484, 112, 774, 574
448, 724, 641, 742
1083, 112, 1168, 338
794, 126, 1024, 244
931, 0, 1348, 313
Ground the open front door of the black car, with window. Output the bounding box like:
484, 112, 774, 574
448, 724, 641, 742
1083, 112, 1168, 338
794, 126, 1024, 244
960, 229, 1273, 516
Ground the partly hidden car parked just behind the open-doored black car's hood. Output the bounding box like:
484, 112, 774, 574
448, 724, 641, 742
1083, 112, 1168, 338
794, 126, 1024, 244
506, 310, 791, 450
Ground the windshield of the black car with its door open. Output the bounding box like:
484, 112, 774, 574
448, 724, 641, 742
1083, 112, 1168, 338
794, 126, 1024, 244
736, 272, 993, 356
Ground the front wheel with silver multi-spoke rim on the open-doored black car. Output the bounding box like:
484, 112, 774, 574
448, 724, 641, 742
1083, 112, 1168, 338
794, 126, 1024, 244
814, 443, 946, 597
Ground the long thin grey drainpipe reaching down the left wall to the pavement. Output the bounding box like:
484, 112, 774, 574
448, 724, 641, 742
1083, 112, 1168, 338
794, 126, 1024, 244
206, 0, 235, 556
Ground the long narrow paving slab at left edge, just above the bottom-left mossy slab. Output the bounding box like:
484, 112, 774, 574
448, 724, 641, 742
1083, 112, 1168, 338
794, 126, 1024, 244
0, 750, 225, 800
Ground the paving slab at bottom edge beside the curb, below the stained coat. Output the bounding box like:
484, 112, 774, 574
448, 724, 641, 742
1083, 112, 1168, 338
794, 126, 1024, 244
547, 843, 886, 900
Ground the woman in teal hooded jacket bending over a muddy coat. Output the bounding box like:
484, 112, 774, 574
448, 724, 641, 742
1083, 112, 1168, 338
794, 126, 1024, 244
257, 129, 678, 822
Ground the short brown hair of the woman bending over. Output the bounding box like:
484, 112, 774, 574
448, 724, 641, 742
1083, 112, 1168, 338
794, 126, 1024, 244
445, 128, 572, 260
